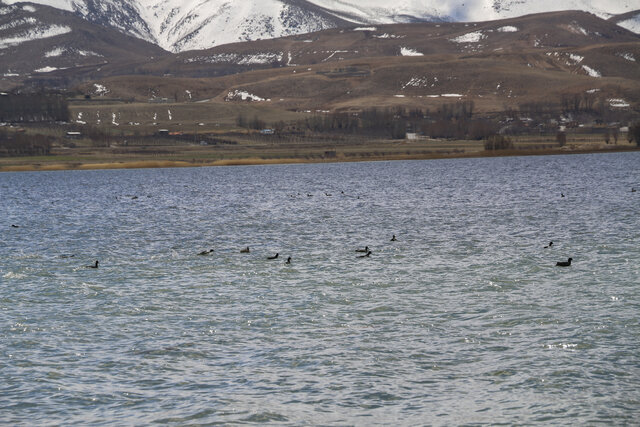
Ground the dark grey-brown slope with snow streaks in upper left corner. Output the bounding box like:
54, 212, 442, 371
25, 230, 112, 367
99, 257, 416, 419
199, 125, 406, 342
0, 4, 168, 89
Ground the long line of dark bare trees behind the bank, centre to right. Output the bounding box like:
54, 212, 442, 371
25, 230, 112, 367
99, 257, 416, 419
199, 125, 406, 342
237, 96, 637, 142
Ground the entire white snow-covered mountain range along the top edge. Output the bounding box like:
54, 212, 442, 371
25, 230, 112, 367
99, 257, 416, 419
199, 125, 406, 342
4, 0, 640, 52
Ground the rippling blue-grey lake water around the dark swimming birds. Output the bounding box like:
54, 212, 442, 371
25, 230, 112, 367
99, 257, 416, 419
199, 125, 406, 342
0, 153, 640, 425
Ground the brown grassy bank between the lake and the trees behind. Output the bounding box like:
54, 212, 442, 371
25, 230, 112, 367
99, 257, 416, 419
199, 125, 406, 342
0, 141, 640, 172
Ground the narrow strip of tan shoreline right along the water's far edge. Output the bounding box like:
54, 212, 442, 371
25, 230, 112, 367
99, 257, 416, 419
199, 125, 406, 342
0, 146, 640, 172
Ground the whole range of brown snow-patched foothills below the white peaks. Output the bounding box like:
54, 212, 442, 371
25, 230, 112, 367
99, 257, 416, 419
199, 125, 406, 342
0, 4, 640, 113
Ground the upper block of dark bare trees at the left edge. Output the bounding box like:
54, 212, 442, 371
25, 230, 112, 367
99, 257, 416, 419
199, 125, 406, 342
0, 92, 70, 123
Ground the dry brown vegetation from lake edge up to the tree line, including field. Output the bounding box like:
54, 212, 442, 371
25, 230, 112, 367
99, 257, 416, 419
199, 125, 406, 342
0, 130, 637, 172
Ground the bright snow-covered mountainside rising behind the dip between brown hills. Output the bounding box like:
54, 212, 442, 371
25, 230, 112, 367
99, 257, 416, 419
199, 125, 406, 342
0, 0, 347, 52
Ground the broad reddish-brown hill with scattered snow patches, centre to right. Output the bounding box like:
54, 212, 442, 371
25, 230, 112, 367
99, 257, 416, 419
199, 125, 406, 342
66, 12, 640, 113
